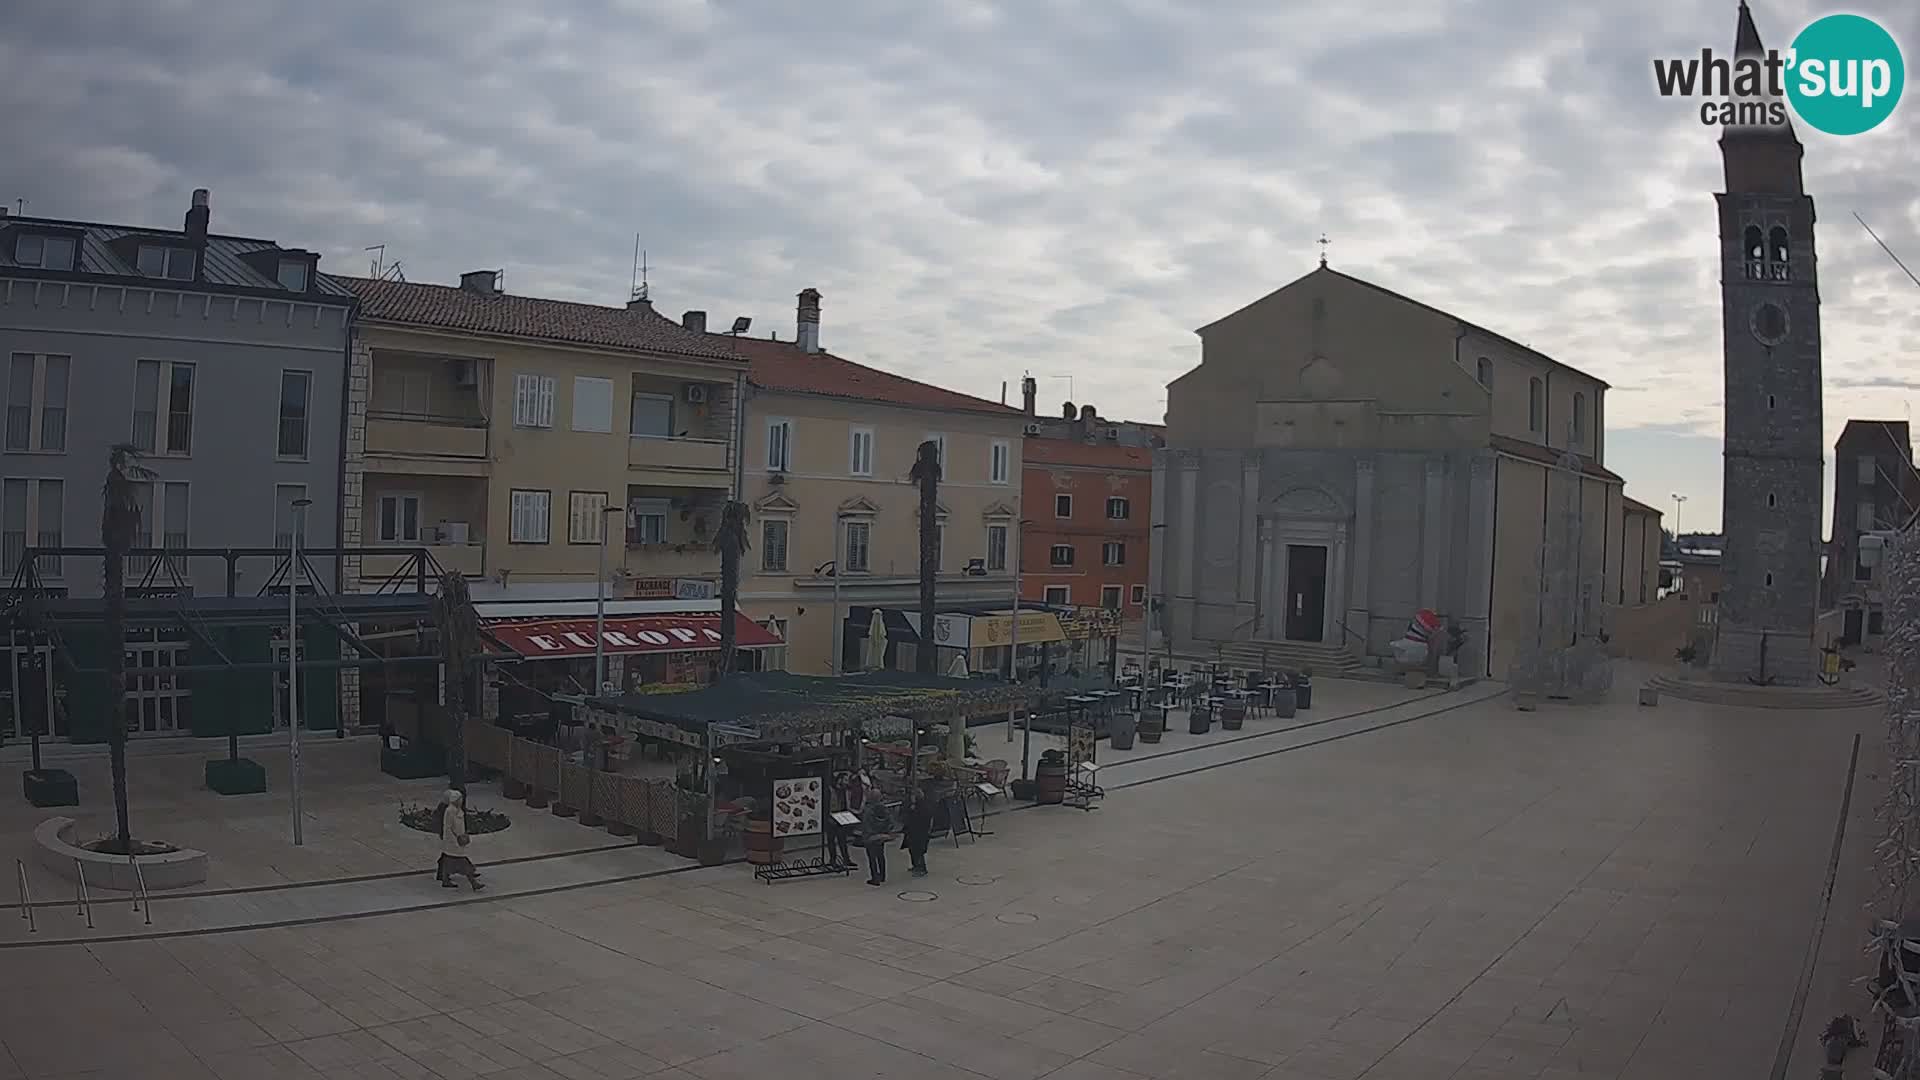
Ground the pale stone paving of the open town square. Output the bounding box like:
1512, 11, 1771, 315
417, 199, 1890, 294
0, 680, 1880, 1080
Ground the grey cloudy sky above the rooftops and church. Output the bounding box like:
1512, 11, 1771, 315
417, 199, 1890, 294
0, 0, 1920, 527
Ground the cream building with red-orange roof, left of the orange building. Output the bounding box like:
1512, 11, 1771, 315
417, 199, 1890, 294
729, 288, 1025, 675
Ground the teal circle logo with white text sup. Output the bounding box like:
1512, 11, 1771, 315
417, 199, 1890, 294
1786, 15, 1907, 135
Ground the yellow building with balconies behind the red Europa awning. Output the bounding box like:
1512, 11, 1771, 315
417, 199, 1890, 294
342, 271, 779, 723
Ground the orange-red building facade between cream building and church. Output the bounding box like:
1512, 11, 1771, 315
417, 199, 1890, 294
1020, 436, 1154, 621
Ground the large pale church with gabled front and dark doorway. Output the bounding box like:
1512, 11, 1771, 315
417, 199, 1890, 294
1150, 263, 1651, 676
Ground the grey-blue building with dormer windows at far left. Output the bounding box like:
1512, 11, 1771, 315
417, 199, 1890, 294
0, 188, 353, 742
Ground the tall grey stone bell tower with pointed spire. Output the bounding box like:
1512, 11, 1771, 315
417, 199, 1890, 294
1713, 2, 1826, 686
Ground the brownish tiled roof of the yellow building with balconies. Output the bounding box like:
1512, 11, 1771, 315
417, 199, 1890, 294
334, 277, 741, 359
